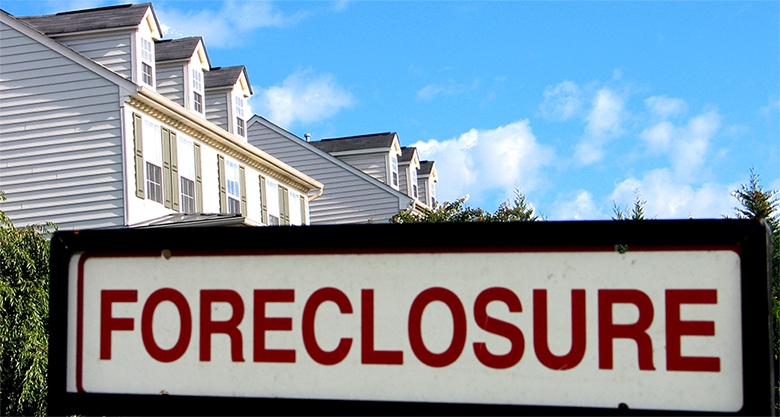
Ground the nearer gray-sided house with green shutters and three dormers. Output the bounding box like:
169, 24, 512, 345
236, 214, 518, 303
0, 3, 323, 229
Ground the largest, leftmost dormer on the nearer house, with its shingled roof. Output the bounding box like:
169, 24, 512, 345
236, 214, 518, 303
18, 3, 162, 88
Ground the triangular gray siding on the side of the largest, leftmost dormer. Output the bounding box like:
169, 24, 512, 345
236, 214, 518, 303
55, 32, 133, 80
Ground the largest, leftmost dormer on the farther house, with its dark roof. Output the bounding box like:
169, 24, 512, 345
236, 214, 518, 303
311, 132, 403, 191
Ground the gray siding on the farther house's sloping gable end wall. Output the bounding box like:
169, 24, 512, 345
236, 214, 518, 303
248, 123, 405, 224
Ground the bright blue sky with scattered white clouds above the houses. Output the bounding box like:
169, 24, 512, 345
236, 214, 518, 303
7, 0, 780, 220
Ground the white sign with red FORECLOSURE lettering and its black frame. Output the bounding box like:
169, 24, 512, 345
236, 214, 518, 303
52, 220, 772, 414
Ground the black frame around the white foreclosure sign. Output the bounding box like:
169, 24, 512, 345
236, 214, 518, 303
48, 219, 775, 415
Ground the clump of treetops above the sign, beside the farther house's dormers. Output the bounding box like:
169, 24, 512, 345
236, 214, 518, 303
390, 190, 544, 224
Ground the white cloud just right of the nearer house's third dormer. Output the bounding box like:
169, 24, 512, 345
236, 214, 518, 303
252, 69, 357, 127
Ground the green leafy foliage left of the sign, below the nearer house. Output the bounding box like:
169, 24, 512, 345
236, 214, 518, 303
0, 193, 54, 415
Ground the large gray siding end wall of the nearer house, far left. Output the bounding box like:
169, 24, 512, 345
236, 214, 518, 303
0, 24, 124, 230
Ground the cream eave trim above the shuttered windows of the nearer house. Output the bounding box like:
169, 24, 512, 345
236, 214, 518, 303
130, 87, 323, 192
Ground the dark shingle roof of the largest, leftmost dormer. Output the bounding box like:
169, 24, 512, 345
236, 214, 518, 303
17, 3, 160, 36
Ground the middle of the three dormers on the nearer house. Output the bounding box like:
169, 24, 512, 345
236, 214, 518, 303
154, 36, 211, 117
